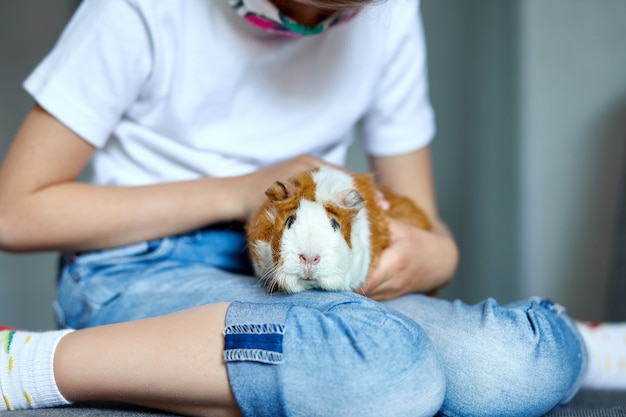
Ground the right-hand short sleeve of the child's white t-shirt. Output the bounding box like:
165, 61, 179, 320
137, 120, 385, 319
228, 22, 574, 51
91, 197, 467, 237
363, 0, 435, 156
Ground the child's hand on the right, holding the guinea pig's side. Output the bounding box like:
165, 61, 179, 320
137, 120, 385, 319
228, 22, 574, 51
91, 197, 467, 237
357, 218, 458, 301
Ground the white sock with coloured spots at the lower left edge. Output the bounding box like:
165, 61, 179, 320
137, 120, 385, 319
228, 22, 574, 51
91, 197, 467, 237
0, 330, 72, 410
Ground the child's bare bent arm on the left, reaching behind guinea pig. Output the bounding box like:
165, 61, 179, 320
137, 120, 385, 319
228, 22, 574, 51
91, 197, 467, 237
0, 106, 322, 251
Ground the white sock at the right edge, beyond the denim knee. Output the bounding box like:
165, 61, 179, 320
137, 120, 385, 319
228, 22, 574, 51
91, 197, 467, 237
576, 322, 626, 390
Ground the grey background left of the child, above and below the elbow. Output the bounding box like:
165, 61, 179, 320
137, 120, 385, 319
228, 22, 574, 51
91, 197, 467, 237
0, 0, 76, 330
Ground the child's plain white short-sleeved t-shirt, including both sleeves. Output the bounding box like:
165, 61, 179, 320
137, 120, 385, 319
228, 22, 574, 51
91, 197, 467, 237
24, 0, 434, 185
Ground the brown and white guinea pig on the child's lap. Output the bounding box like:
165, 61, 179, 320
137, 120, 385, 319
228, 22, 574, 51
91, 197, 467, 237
246, 166, 432, 293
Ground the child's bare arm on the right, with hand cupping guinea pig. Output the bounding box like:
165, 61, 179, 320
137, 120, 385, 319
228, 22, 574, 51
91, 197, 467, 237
361, 148, 458, 300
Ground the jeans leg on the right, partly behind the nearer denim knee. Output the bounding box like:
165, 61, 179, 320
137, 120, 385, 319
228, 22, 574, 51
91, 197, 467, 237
385, 295, 587, 417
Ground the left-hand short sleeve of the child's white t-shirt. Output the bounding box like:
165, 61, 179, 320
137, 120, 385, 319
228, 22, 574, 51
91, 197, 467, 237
24, 0, 151, 147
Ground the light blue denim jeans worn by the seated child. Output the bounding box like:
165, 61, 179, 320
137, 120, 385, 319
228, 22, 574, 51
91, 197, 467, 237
56, 231, 587, 417
